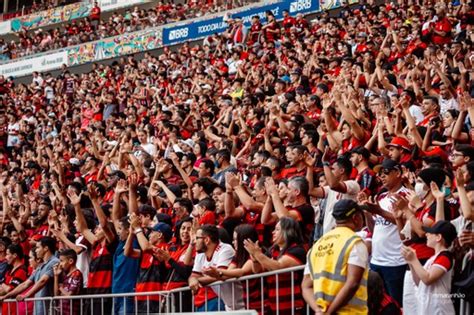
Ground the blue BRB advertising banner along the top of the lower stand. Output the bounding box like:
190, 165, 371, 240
163, 0, 320, 45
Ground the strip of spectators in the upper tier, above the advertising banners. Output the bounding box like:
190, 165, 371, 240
0, 0, 255, 61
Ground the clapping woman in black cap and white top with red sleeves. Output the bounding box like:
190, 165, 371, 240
402, 220, 457, 315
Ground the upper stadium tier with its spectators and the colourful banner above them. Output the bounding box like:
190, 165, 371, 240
0, 0, 255, 62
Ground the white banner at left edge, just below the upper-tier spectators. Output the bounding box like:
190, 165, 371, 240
0, 51, 67, 77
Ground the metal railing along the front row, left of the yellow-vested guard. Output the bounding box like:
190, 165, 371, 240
4, 265, 310, 315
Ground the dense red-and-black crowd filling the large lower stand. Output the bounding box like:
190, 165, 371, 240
0, 1, 474, 314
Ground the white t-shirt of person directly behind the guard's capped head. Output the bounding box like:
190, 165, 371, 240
323, 180, 360, 233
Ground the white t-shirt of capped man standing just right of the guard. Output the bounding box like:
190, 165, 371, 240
370, 187, 407, 267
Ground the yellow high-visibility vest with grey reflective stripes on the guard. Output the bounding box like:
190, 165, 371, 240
308, 227, 369, 315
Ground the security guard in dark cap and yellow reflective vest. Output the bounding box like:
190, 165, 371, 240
302, 199, 369, 315
